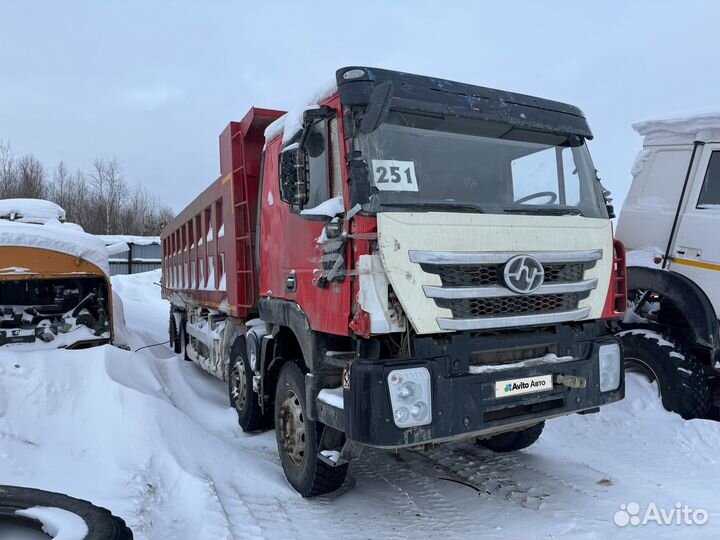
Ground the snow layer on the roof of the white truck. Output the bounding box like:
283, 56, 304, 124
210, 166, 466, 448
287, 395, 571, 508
632, 106, 720, 146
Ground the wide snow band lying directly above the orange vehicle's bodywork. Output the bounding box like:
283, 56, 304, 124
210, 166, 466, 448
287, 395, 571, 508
0, 219, 110, 275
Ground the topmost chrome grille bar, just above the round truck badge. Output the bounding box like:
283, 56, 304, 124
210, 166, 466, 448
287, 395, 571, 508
408, 249, 602, 264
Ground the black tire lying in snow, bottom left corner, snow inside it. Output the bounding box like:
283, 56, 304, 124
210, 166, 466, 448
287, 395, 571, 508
0, 486, 133, 540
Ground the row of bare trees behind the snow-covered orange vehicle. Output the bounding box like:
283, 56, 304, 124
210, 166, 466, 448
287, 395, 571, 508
0, 141, 173, 236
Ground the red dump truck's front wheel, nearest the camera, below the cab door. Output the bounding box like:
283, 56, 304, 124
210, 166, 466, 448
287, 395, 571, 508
275, 362, 348, 497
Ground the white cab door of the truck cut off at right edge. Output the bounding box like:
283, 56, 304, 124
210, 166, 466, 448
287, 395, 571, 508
670, 143, 720, 314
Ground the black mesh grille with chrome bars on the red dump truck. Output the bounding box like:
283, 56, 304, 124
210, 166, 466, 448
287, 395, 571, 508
410, 250, 602, 330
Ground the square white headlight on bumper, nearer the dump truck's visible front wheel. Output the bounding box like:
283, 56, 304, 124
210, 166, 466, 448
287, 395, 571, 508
388, 368, 432, 428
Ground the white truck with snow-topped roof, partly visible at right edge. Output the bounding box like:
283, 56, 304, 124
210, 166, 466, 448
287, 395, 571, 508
617, 112, 720, 417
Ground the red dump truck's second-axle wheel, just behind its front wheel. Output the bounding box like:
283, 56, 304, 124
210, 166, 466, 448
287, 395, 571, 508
225, 338, 269, 431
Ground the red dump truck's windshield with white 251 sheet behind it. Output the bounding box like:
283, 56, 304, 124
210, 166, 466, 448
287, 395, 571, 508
355, 112, 607, 218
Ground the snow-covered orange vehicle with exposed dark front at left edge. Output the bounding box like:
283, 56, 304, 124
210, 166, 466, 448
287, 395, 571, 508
0, 199, 114, 348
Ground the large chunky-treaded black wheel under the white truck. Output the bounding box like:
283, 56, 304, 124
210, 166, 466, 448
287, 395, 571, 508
617, 329, 712, 420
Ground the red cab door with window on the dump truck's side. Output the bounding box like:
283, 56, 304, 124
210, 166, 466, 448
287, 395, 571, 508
283, 112, 350, 335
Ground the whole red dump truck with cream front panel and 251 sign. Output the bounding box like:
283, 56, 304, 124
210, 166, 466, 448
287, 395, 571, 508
161, 66, 626, 496
